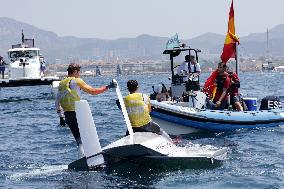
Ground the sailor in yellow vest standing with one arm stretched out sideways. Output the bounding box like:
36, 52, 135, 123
56, 64, 116, 151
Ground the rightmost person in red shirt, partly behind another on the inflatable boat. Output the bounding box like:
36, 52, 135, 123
228, 71, 243, 111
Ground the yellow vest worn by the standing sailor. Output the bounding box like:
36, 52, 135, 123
58, 77, 80, 112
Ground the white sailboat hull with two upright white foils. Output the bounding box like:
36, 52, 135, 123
68, 79, 227, 170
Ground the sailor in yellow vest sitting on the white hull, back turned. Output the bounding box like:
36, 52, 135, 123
124, 80, 169, 138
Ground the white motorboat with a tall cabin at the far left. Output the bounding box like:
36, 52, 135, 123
0, 31, 59, 87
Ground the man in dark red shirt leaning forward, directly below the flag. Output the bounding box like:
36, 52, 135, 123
213, 62, 231, 110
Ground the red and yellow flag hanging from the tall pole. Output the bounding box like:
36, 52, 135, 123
221, 0, 240, 63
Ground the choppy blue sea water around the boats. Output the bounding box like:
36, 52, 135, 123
0, 73, 284, 188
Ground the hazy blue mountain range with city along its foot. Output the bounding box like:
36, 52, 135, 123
0, 17, 284, 63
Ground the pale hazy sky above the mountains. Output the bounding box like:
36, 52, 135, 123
0, 0, 284, 39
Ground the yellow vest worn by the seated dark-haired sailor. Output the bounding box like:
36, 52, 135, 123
125, 93, 151, 127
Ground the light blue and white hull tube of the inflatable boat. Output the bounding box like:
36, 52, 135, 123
151, 100, 284, 135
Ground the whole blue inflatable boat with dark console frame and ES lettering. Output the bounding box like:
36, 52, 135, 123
150, 47, 284, 135
